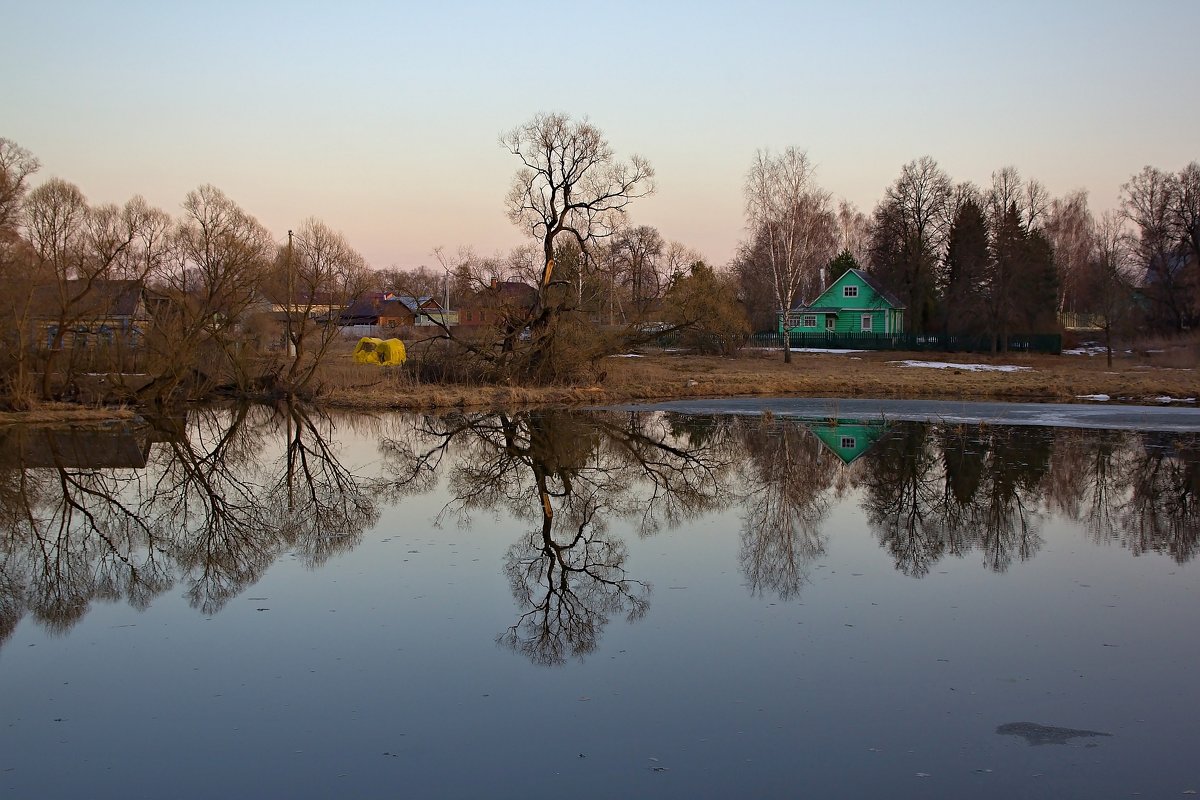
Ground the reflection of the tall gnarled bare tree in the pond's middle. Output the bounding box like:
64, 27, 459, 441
385, 411, 730, 664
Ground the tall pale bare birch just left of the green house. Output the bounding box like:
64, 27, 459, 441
745, 148, 838, 362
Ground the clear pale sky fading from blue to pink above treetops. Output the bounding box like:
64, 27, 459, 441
0, 0, 1200, 269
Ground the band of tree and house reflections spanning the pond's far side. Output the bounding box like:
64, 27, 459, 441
0, 407, 1200, 664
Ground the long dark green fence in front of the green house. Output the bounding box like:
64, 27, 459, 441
658, 332, 1062, 355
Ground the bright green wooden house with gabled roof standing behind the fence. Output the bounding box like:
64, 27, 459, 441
779, 269, 905, 335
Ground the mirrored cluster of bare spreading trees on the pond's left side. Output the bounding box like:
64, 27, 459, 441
0, 407, 378, 637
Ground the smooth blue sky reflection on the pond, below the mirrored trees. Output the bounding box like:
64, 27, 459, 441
0, 417, 1200, 798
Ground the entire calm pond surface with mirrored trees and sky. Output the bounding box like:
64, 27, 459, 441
0, 409, 1200, 798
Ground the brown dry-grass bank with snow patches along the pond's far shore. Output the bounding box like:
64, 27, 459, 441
0, 350, 1200, 425
